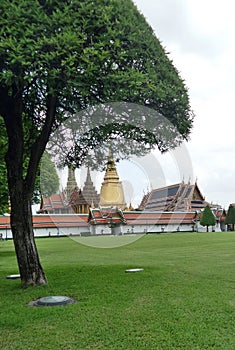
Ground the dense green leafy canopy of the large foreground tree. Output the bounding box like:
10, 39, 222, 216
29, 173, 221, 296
0, 0, 193, 144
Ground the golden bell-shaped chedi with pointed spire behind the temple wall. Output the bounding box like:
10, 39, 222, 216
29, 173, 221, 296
99, 149, 126, 209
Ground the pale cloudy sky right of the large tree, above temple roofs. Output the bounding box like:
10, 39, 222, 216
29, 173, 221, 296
124, 0, 235, 208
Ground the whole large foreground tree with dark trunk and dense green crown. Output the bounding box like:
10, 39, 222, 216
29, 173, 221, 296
0, 0, 193, 287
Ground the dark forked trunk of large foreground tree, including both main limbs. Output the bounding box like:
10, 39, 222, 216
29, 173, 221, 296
0, 84, 57, 287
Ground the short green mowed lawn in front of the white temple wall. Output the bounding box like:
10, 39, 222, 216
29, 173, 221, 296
0, 232, 235, 350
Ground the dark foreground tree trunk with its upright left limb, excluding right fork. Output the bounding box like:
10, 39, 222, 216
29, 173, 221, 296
0, 86, 47, 287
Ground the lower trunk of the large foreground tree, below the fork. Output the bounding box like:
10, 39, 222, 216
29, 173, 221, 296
11, 186, 47, 288
